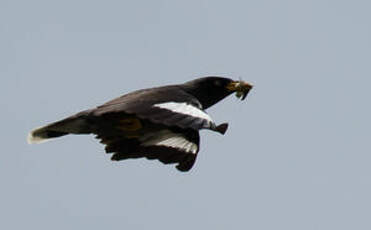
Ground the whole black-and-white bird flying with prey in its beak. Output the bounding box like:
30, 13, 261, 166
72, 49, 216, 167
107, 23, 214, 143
27, 76, 253, 172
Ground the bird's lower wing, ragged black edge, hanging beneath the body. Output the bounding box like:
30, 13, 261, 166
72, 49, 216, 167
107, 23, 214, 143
97, 128, 200, 171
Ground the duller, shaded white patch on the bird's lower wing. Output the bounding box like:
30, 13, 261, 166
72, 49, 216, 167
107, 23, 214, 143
139, 130, 198, 154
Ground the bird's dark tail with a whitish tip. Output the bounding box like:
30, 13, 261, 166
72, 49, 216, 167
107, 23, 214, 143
27, 111, 93, 144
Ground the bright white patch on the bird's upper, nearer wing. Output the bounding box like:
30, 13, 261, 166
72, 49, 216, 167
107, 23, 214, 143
153, 102, 213, 123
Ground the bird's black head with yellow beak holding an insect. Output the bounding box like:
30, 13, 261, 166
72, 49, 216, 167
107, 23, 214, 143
182, 77, 253, 109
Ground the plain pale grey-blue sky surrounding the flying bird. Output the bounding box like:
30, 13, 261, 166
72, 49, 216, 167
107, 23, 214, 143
0, 0, 371, 230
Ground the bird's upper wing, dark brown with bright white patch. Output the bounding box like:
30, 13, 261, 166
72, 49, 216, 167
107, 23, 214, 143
92, 86, 221, 133
